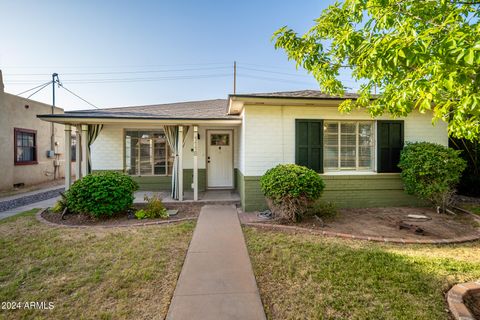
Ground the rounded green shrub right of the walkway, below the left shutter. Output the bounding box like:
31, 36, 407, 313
260, 164, 325, 221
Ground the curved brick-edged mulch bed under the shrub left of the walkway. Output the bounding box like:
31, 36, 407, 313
41, 204, 201, 227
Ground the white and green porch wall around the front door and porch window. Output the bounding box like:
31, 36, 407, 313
91, 123, 240, 191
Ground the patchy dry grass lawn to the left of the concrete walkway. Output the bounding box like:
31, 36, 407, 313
0, 210, 195, 319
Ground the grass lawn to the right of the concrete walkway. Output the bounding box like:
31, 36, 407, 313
245, 228, 480, 320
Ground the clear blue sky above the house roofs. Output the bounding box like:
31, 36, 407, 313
0, 0, 358, 110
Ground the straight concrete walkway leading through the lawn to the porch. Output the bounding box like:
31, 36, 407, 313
167, 205, 265, 320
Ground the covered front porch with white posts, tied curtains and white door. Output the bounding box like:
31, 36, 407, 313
38, 115, 240, 203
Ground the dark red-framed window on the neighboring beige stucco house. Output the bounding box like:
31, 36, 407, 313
14, 128, 38, 165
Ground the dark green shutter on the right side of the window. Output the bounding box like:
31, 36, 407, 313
377, 120, 403, 172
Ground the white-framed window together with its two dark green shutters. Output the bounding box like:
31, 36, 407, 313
295, 119, 404, 173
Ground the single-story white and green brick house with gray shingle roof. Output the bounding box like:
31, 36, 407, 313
39, 90, 448, 211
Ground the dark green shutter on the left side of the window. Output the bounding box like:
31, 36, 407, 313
295, 119, 323, 173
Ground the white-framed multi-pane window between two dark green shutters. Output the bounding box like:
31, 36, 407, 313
323, 120, 375, 171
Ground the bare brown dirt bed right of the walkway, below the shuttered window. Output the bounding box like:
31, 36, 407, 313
242, 207, 480, 240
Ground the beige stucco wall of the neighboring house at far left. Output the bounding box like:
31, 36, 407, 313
0, 90, 65, 190
